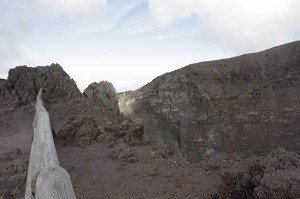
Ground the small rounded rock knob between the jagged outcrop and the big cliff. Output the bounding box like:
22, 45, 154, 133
83, 81, 120, 113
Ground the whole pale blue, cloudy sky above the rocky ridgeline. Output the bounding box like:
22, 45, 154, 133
0, 0, 300, 92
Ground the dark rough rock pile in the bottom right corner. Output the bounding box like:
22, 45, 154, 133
213, 148, 300, 199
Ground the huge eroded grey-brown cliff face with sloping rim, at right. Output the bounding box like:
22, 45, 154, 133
119, 41, 300, 161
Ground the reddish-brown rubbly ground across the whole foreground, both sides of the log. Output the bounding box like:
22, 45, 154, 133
0, 102, 300, 199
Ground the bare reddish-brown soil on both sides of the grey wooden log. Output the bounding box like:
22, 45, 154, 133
0, 110, 220, 198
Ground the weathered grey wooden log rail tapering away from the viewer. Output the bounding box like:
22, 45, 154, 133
25, 89, 76, 199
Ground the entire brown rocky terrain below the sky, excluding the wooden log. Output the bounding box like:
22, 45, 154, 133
0, 42, 300, 199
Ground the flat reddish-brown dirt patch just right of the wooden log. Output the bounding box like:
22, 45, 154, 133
58, 141, 220, 198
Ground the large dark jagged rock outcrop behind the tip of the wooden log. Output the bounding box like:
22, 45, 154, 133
0, 64, 81, 105
